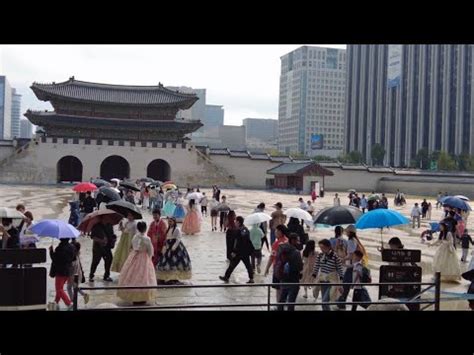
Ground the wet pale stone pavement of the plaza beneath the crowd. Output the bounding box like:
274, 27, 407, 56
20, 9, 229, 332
0, 185, 474, 310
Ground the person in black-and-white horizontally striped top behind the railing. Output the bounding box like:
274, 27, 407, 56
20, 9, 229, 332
313, 239, 344, 311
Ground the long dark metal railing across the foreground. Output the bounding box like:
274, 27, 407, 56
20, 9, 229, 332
73, 272, 441, 311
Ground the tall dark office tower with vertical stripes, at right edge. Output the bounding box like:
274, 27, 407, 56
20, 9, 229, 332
345, 45, 474, 166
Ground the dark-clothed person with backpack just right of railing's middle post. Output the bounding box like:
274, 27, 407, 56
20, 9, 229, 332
278, 233, 303, 311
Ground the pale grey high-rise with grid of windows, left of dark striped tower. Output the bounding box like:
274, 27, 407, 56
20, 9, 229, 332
278, 46, 346, 156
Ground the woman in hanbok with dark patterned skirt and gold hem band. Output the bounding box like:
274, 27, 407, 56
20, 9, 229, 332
156, 217, 192, 284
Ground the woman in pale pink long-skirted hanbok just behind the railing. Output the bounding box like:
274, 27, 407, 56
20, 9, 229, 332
117, 222, 157, 304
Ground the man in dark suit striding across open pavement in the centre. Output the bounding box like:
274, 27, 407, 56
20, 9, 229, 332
219, 216, 255, 283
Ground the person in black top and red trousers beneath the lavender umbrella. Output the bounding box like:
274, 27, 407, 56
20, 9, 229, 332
49, 238, 74, 310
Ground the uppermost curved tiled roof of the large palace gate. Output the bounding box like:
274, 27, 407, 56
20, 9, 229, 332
31, 77, 198, 109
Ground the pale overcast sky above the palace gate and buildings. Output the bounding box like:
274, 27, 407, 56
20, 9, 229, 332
0, 45, 345, 125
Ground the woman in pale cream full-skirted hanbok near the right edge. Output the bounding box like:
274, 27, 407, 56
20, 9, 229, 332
430, 222, 461, 281
